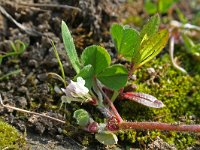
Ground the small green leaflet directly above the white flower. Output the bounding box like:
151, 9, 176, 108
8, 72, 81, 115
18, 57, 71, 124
75, 65, 94, 89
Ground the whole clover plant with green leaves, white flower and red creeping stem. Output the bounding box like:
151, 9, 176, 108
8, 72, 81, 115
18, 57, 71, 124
61, 15, 199, 145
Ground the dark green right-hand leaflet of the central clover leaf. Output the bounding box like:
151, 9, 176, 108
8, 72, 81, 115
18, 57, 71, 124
97, 65, 128, 90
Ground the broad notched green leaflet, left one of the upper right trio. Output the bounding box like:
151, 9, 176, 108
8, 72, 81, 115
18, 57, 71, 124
110, 24, 141, 58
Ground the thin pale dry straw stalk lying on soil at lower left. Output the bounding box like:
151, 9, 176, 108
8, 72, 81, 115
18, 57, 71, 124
0, 95, 65, 123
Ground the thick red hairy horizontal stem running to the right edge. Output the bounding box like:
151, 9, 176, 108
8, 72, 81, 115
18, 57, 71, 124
119, 122, 200, 132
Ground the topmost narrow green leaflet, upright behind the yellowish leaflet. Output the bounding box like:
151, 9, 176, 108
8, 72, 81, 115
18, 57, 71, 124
140, 14, 160, 40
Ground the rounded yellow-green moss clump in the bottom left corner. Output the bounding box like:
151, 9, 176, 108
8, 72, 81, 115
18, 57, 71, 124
0, 121, 26, 150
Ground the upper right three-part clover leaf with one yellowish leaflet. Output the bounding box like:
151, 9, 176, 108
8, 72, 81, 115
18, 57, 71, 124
111, 15, 169, 69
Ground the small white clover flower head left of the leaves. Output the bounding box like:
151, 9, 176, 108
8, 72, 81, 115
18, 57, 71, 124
61, 77, 92, 104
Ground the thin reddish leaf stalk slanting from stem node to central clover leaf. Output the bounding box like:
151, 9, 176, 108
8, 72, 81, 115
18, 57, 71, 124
95, 78, 123, 123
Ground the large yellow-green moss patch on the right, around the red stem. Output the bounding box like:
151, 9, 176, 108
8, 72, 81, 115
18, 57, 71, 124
117, 52, 200, 149
